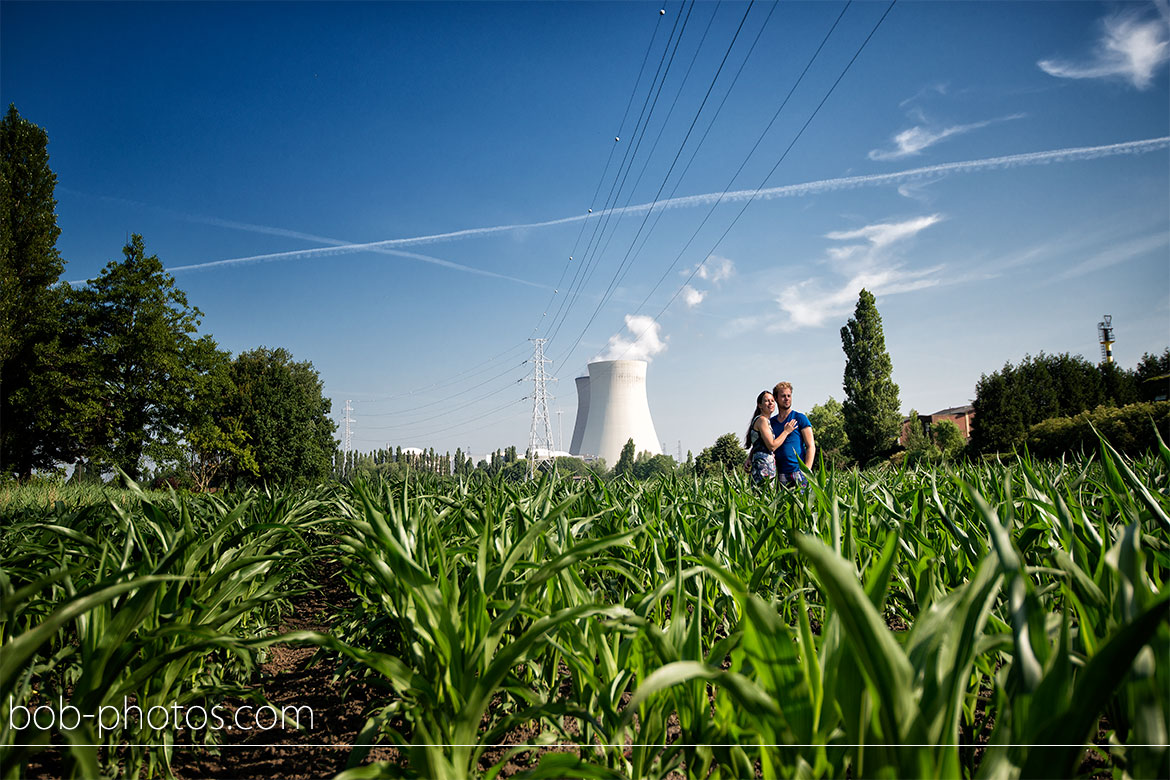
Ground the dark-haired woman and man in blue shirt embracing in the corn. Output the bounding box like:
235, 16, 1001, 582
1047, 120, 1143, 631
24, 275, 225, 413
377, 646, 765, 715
743, 382, 817, 486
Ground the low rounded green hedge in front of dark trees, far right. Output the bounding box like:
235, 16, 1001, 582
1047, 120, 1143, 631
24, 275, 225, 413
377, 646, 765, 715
1025, 401, 1170, 457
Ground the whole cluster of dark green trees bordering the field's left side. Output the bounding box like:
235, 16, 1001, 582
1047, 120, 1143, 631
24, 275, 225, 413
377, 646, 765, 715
0, 106, 337, 489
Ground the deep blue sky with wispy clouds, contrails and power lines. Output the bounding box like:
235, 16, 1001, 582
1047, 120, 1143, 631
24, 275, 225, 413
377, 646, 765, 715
0, 0, 1170, 456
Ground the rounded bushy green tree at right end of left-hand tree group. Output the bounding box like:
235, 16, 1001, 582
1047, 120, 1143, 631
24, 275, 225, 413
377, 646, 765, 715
229, 347, 337, 484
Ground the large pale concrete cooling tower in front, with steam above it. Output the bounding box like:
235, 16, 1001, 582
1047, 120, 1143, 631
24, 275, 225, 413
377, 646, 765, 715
573, 360, 662, 468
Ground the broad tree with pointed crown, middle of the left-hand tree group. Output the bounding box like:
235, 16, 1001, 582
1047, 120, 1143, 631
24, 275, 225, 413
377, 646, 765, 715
75, 234, 221, 478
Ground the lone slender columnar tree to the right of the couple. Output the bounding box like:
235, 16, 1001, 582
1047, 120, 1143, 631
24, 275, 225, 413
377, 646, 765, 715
841, 289, 902, 465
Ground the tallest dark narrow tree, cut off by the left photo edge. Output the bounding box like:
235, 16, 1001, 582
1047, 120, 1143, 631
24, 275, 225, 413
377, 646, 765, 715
0, 105, 68, 476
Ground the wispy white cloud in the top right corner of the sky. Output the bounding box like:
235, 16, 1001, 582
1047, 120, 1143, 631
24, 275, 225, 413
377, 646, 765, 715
1037, 10, 1170, 89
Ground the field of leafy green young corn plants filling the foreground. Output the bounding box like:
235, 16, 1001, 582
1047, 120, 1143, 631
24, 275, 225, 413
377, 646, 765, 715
0, 430, 1170, 779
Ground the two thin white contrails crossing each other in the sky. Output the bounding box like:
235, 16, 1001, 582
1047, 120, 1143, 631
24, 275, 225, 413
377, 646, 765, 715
77, 136, 1170, 277
